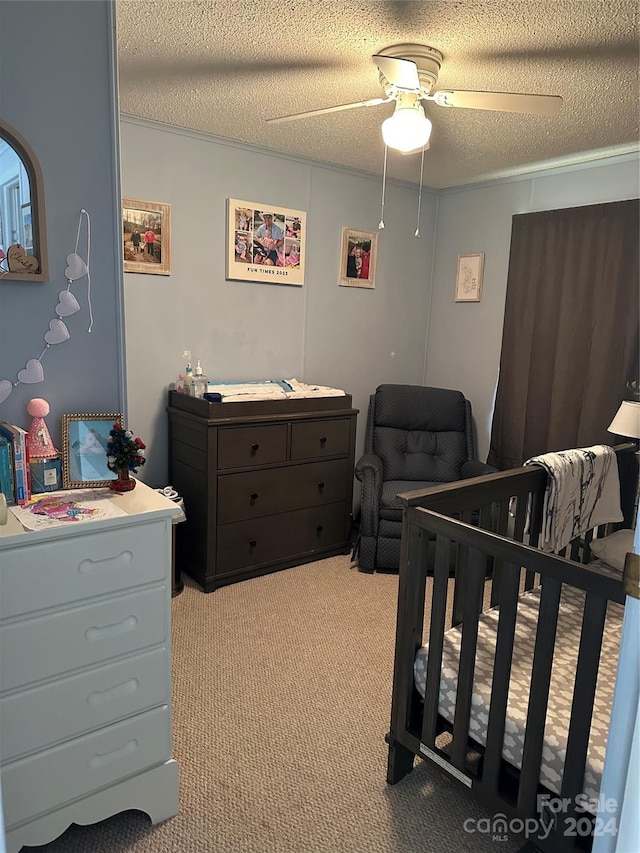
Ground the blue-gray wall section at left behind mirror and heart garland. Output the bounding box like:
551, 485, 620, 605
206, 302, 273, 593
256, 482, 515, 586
0, 0, 125, 446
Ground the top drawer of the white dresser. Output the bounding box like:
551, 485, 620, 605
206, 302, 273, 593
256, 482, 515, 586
0, 519, 171, 619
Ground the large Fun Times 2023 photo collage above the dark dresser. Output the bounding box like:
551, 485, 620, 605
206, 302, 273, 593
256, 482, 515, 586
226, 198, 307, 287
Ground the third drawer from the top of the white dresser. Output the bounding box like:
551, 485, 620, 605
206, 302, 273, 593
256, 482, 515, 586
0, 648, 171, 763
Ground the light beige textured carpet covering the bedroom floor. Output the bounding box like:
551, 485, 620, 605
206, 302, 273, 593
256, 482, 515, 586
26, 556, 521, 853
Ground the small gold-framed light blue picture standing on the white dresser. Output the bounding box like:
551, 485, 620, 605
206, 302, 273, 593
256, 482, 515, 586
62, 412, 122, 489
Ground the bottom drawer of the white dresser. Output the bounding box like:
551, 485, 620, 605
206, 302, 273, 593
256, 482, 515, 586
2, 705, 171, 830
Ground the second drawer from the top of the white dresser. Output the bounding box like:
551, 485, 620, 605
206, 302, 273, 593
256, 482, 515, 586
0, 585, 169, 691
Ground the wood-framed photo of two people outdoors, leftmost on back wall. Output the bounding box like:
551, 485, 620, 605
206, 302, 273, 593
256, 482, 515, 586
122, 198, 171, 275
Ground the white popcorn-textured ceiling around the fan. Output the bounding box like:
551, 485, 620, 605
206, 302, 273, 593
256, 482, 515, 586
117, 0, 640, 188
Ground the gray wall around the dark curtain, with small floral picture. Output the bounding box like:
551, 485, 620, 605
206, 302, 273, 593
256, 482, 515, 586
425, 155, 640, 459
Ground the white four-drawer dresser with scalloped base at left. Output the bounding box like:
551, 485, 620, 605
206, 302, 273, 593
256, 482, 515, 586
0, 482, 178, 853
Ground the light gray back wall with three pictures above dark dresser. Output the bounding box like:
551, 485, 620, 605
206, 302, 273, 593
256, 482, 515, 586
120, 117, 436, 485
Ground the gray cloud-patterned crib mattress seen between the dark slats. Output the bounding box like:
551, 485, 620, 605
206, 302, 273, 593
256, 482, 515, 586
414, 585, 624, 800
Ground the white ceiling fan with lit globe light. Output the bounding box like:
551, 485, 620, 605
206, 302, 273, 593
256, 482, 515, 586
267, 44, 563, 154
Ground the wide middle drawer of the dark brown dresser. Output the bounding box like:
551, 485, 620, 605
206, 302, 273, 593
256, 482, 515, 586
218, 459, 349, 524
